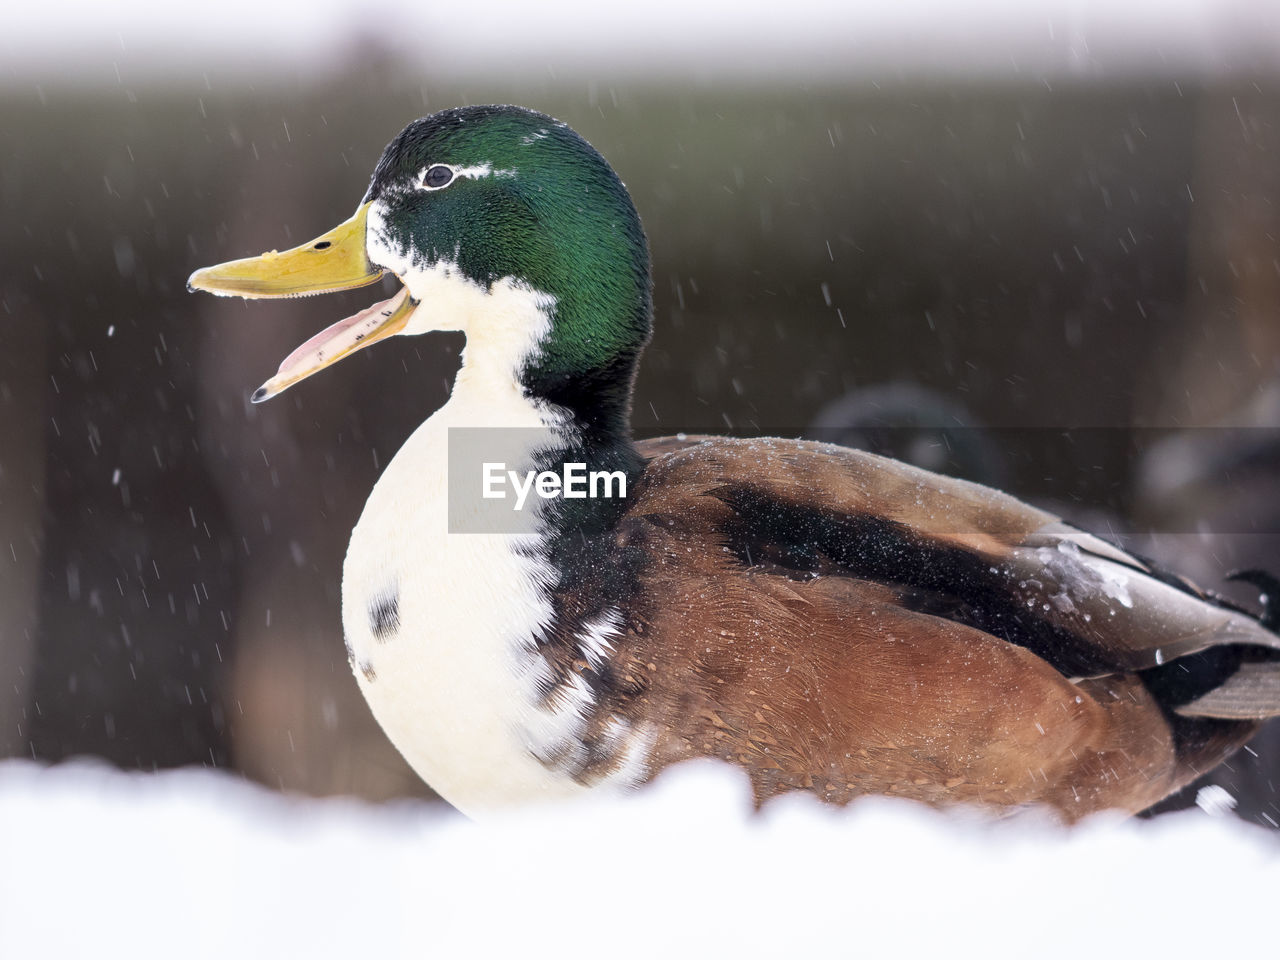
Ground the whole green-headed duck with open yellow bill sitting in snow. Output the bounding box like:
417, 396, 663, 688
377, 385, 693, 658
188, 105, 1280, 822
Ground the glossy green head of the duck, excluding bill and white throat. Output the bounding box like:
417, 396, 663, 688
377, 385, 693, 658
365, 106, 650, 424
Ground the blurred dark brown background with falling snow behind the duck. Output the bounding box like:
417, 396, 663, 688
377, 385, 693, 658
0, 0, 1280, 827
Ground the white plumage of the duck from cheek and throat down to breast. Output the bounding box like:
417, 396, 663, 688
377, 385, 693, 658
342, 264, 648, 815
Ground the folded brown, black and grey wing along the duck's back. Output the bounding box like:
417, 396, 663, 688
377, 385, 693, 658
630, 438, 1280, 686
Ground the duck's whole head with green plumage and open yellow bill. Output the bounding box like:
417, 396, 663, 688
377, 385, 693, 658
189, 106, 652, 430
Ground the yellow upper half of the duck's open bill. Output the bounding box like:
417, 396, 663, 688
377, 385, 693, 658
187, 204, 383, 298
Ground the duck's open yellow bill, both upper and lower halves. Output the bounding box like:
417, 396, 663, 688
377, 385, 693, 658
187, 204, 417, 403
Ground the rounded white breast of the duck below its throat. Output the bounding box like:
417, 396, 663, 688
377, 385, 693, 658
342, 385, 599, 814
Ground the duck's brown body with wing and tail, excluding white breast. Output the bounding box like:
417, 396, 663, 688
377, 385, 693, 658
547, 438, 1280, 817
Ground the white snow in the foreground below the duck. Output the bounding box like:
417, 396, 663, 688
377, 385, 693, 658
0, 762, 1280, 960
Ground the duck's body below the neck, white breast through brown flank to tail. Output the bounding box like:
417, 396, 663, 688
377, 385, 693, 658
343, 419, 1274, 819
